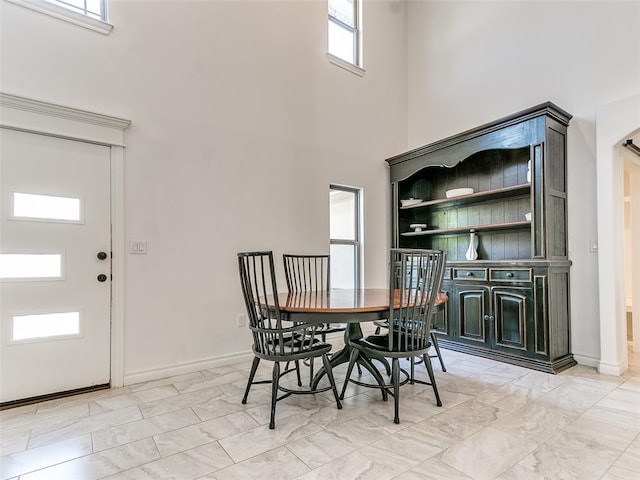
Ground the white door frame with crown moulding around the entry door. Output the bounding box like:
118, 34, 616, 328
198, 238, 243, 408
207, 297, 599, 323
0, 92, 131, 387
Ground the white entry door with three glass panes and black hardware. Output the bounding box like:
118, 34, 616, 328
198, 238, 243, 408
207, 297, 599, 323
0, 129, 111, 403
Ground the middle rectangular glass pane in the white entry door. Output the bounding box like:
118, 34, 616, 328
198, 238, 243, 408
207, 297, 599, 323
0, 253, 62, 280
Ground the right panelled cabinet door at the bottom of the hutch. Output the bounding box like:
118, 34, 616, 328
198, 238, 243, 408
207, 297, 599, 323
491, 287, 534, 353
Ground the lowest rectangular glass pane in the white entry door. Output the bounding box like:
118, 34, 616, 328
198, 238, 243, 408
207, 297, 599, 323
11, 312, 80, 341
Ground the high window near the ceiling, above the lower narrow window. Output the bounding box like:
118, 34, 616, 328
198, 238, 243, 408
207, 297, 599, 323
327, 0, 363, 74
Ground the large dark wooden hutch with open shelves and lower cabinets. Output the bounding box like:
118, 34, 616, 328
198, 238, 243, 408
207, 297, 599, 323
386, 102, 576, 373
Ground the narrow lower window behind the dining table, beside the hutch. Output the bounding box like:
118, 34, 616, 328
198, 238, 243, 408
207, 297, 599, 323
329, 185, 361, 289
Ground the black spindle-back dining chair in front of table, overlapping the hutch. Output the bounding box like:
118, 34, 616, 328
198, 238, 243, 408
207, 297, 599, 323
340, 248, 444, 423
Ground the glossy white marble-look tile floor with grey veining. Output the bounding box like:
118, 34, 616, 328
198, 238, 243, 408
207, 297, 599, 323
0, 344, 640, 480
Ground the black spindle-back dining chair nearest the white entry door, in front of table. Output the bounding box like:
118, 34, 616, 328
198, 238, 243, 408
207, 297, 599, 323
238, 251, 342, 429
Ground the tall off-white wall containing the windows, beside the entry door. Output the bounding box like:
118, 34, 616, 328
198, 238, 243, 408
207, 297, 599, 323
0, 0, 407, 381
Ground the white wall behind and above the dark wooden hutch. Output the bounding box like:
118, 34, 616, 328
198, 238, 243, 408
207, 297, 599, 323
407, 0, 640, 366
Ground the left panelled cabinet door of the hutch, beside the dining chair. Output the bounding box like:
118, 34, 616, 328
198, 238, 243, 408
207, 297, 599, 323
455, 283, 490, 346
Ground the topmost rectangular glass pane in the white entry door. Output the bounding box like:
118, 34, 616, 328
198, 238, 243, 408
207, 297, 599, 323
13, 192, 81, 222
